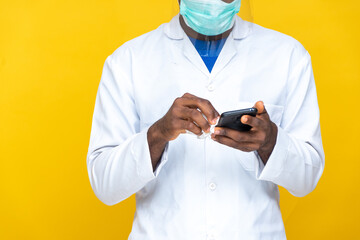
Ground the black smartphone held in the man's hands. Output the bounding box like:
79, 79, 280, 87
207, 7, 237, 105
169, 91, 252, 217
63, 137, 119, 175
216, 108, 257, 132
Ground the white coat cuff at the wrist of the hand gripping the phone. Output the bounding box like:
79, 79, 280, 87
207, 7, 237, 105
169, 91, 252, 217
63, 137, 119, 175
255, 127, 290, 181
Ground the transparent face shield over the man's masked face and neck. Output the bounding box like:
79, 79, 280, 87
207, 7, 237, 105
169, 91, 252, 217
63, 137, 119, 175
172, 0, 254, 42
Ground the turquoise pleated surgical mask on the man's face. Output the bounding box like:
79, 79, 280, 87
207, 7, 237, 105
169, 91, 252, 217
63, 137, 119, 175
180, 0, 241, 36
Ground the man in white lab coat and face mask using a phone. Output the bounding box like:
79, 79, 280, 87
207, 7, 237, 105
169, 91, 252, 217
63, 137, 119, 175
87, 0, 324, 240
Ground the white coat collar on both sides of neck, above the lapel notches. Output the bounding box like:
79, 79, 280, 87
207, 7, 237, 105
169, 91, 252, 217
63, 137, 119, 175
164, 14, 252, 40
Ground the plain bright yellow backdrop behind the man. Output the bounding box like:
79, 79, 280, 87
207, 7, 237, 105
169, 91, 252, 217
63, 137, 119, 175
0, 0, 360, 239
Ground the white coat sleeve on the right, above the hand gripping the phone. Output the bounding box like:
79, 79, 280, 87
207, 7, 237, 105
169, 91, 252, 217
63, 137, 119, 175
256, 49, 325, 197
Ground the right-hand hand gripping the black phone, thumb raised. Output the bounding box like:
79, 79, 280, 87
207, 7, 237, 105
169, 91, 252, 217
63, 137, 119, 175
211, 101, 278, 164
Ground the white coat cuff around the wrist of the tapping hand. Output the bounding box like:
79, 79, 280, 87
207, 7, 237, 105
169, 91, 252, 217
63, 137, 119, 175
131, 126, 169, 182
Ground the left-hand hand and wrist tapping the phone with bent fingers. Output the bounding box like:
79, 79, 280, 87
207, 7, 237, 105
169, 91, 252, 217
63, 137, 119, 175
148, 93, 220, 169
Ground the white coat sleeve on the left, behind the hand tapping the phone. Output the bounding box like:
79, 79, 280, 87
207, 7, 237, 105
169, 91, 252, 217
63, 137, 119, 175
86, 50, 168, 205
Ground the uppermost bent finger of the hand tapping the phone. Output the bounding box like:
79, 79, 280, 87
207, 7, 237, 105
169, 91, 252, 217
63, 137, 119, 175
182, 94, 220, 124
